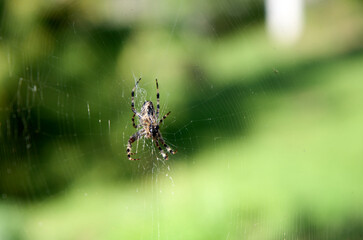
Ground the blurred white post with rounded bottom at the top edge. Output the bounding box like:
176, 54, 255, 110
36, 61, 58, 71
265, 0, 304, 45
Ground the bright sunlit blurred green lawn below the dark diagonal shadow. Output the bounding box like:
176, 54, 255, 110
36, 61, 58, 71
2, 47, 363, 239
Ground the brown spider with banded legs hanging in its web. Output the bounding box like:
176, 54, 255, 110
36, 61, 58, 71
126, 78, 177, 161
